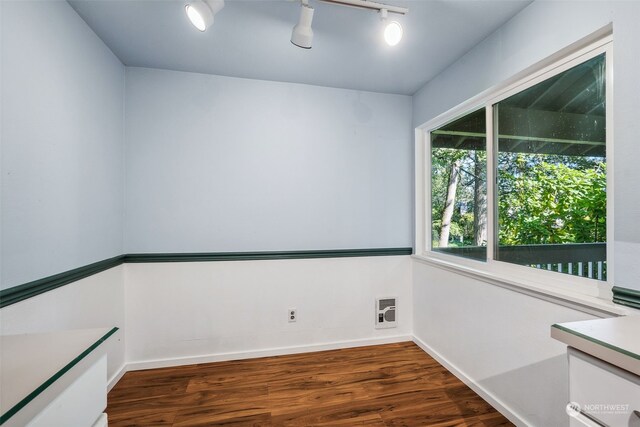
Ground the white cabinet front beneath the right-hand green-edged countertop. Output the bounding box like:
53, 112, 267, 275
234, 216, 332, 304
568, 347, 640, 427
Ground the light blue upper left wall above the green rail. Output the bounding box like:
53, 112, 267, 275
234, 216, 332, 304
0, 1, 124, 288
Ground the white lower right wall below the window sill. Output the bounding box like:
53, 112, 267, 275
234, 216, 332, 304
413, 261, 594, 427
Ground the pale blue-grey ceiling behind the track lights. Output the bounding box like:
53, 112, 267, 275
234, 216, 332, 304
69, 0, 531, 95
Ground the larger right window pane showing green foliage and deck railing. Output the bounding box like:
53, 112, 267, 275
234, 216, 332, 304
493, 54, 607, 280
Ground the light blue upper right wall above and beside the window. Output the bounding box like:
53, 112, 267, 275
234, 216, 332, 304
413, 0, 640, 289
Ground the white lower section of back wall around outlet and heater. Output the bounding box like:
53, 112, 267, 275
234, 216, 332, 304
125, 256, 413, 366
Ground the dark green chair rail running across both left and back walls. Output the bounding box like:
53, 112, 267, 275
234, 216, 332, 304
0, 248, 413, 308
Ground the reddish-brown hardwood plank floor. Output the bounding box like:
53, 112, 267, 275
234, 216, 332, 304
107, 342, 512, 427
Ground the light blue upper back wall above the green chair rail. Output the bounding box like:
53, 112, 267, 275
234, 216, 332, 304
125, 68, 413, 253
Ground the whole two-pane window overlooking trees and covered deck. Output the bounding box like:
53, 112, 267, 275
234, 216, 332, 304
417, 38, 611, 283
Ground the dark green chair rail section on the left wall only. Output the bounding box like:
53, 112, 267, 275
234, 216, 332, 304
0, 255, 125, 308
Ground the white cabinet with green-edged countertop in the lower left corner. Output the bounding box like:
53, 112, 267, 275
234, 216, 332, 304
0, 328, 118, 427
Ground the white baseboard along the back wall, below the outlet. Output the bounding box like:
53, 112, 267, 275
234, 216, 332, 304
125, 335, 413, 372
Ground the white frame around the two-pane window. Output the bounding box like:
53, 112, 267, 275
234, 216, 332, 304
414, 33, 615, 300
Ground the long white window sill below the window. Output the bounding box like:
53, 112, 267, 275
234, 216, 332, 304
411, 255, 638, 317
